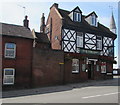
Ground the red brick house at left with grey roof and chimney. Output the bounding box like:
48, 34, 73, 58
0, 16, 34, 89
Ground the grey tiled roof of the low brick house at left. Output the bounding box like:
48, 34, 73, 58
0, 23, 33, 39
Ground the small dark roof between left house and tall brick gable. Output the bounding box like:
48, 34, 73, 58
35, 32, 50, 43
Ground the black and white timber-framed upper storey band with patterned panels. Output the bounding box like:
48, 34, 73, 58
62, 29, 114, 56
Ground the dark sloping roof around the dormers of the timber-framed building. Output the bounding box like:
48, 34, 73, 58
58, 9, 117, 38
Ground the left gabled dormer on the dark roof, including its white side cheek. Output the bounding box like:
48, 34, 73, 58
69, 7, 82, 22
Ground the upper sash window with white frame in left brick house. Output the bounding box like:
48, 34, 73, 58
5, 43, 16, 58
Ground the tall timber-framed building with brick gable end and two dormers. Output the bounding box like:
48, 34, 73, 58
45, 3, 117, 82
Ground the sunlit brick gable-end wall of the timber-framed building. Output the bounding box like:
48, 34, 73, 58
46, 7, 62, 49
